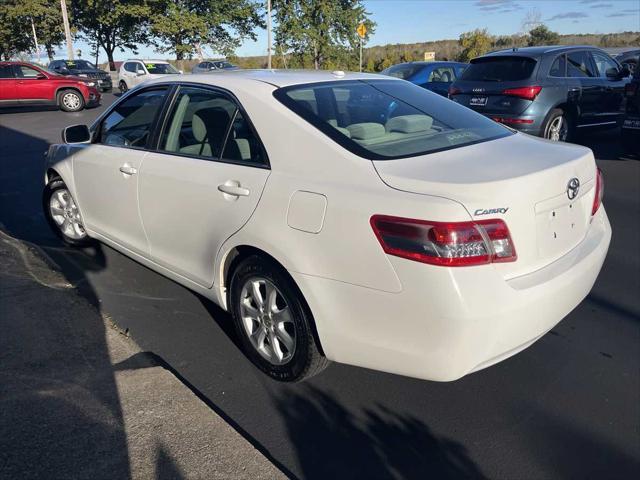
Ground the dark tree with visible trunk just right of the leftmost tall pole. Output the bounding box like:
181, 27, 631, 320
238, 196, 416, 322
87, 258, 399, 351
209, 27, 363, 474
71, 0, 155, 70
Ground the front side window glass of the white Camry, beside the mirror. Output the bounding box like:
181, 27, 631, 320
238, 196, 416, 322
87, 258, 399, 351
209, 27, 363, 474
98, 88, 167, 148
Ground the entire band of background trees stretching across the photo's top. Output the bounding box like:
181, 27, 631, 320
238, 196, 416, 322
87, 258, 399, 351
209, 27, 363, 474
0, 0, 640, 72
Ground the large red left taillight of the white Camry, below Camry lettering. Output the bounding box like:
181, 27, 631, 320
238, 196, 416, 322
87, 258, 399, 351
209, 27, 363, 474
371, 215, 517, 267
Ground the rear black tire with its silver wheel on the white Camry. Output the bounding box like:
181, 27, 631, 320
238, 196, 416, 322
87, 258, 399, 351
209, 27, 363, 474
229, 255, 329, 382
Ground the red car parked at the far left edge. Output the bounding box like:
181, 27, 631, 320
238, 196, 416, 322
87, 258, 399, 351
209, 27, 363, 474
0, 62, 100, 112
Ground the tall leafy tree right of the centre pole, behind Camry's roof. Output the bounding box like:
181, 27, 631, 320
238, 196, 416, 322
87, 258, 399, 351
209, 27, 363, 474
273, 0, 375, 69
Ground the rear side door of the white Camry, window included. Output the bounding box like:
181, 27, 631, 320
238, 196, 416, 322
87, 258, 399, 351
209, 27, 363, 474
139, 86, 270, 287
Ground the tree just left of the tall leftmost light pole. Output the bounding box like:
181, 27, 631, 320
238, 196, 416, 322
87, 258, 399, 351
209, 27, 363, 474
20, 0, 64, 61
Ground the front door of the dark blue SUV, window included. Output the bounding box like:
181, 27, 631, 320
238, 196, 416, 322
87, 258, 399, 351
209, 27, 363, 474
591, 51, 628, 122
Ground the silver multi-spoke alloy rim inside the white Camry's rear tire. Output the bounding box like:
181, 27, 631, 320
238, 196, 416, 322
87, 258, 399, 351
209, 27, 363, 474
240, 277, 296, 365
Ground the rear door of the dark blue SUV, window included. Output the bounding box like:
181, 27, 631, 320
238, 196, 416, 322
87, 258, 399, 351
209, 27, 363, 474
567, 50, 603, 127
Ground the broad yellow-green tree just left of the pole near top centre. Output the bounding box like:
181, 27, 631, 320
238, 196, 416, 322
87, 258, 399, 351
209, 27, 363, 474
151, 0, 264, 60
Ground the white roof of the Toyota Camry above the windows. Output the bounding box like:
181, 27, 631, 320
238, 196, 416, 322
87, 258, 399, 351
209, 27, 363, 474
174, 69, 401, 87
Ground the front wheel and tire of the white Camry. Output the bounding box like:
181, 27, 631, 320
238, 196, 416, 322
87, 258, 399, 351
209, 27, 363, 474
42, 178, 93, 247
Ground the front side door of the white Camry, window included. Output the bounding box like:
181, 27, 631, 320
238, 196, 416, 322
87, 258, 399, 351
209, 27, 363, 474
73, 86, 168, 255
